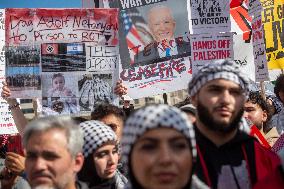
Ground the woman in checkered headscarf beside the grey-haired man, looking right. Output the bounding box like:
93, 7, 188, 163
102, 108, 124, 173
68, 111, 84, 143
78, 120, 127, 189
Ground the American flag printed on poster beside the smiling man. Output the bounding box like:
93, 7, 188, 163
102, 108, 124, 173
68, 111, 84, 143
121, 10, 144, 64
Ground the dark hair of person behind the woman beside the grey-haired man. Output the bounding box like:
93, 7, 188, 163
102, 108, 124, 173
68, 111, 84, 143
91, 103, 126, 121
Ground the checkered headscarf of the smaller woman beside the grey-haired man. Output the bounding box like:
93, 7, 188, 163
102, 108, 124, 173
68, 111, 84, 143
80, 120, 117, 157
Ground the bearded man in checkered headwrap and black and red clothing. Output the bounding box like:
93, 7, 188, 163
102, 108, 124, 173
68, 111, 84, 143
189, 60, 280, 189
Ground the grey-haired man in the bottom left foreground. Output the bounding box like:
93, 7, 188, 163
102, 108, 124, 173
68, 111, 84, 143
23, 116, 87, 189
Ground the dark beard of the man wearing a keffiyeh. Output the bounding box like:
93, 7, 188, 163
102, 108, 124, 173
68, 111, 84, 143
196, 100, 244, 133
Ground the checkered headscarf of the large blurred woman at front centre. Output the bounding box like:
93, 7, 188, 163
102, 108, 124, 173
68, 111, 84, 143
121, 104, 196, 173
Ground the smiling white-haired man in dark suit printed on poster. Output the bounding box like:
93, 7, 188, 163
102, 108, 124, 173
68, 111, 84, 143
134, 6, 190, 65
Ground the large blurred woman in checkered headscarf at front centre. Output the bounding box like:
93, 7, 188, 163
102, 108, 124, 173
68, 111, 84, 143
122, 104, 207, 189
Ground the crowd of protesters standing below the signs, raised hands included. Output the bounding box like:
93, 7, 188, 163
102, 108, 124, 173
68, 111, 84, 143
1, 60, 284, 189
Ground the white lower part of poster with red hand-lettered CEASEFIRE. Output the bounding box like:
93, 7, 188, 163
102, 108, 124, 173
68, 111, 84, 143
120, 57, 192, 98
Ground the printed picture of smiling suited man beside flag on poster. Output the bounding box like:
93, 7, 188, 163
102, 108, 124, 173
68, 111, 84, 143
115, 0, 190, 69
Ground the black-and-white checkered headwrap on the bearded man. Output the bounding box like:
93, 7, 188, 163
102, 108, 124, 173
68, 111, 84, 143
188, 60, 249, 96
